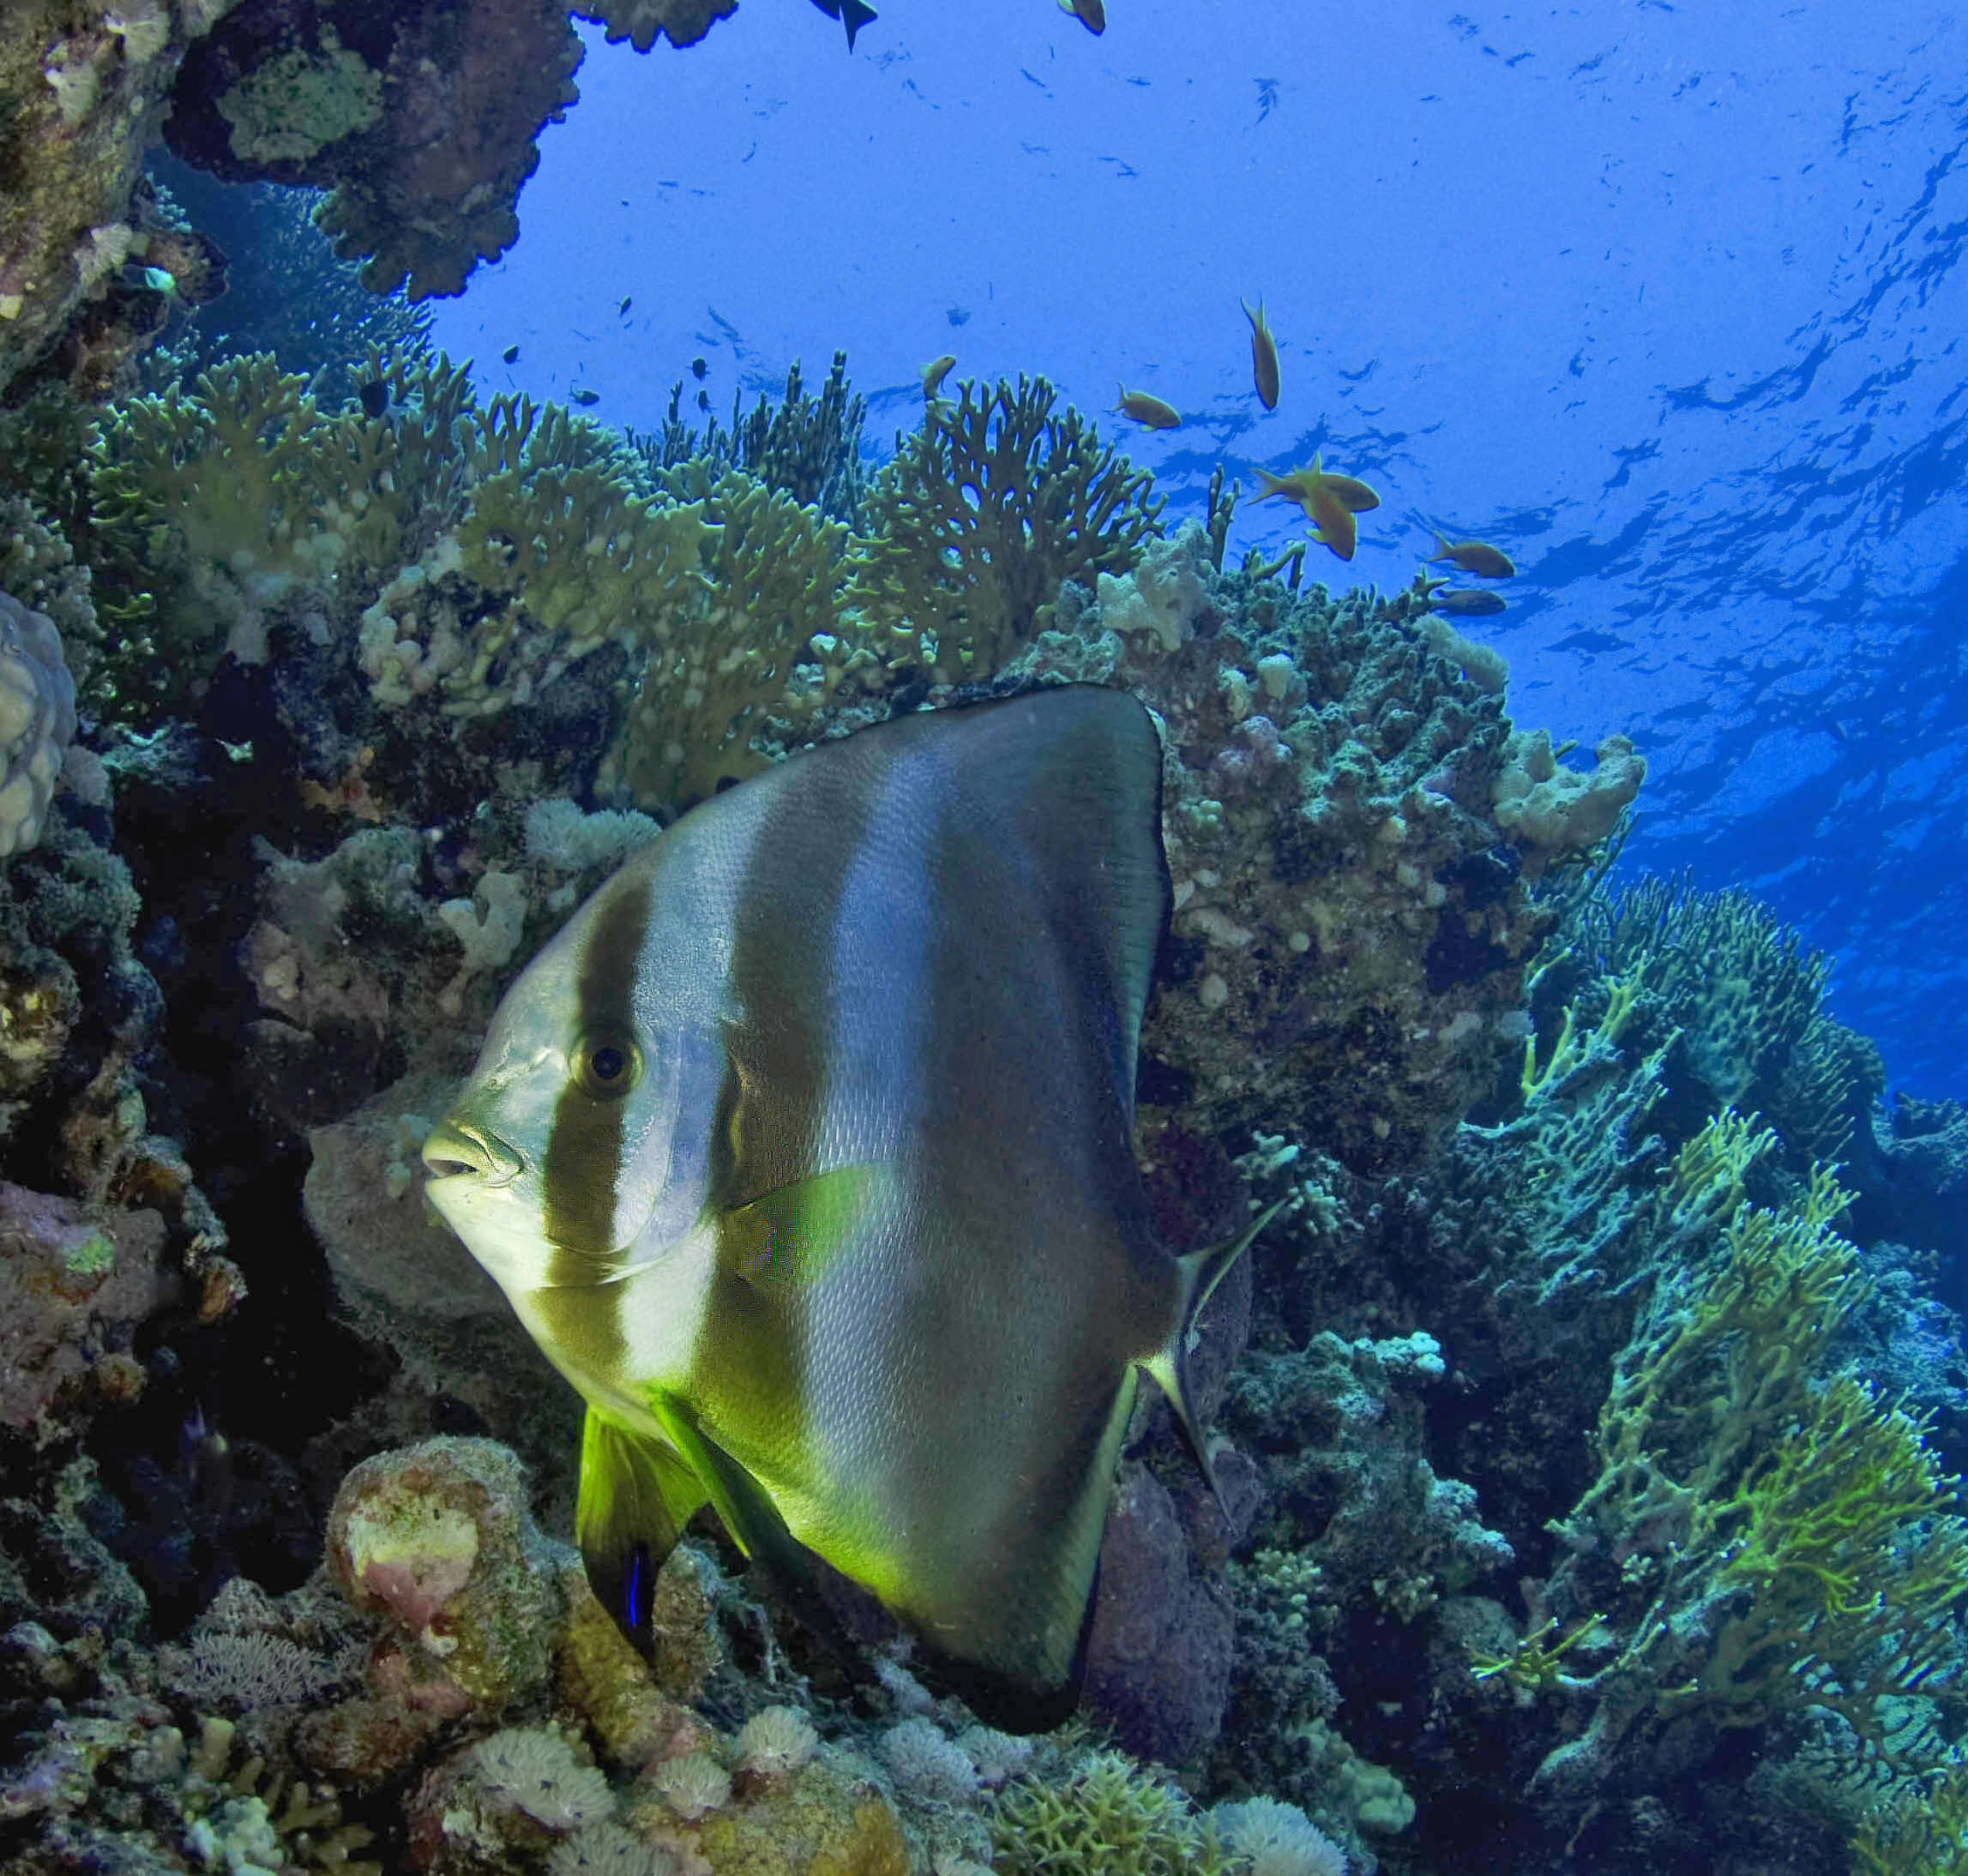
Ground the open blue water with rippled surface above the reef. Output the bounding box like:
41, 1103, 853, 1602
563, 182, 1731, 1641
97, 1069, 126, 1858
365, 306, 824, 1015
418, 0, 1968, 1097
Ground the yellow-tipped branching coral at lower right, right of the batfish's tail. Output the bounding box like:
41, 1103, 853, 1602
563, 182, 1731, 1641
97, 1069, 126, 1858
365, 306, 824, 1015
1539, 1116, 1968, 1794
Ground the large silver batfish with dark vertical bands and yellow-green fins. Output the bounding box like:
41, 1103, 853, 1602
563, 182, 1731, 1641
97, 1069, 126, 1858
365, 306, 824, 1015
423, 685, 1269, 1727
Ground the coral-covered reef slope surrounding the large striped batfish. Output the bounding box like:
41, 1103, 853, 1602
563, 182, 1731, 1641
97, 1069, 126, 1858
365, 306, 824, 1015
0, 251, 1968, 1876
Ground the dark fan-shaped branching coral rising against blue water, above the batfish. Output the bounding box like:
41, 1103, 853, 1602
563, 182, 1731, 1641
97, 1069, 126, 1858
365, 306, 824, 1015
848, 378, 1161, 679
